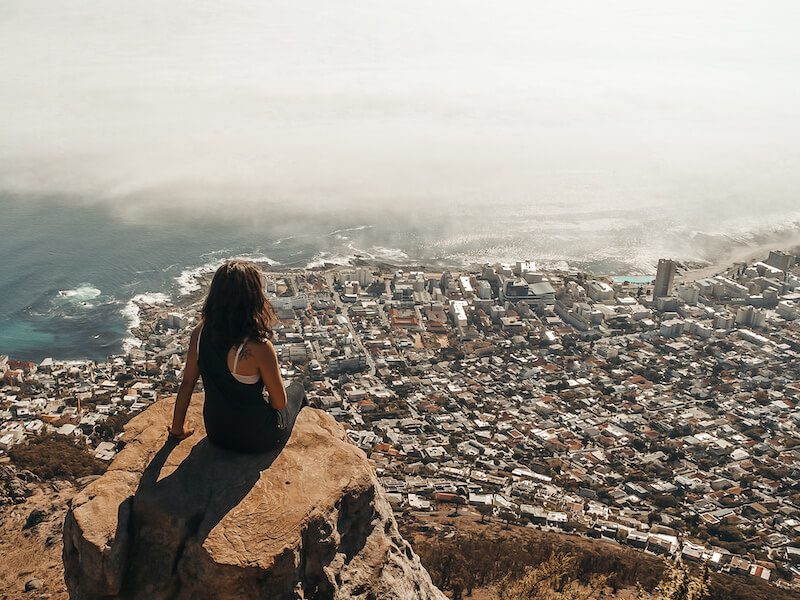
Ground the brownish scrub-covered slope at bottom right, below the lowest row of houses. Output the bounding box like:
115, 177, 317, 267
415, 532, 795, 600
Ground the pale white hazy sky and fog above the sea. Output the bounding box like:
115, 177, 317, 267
0, 0, 800, 224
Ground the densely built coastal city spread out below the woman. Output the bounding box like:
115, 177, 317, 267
0, 251, 800, 589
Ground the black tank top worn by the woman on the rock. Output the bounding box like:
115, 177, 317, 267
197, 329, 281, 452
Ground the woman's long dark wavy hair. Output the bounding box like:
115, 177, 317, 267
202, 260, 277, 349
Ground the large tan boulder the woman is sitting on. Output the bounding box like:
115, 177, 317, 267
64, 394, 444, 600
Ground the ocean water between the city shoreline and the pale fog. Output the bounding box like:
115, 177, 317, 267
0, 196, 798, 360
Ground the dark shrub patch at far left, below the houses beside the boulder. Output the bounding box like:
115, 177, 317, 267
8, 433, 105, 480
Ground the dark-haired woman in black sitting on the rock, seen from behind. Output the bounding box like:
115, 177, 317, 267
169, 260, 306, 452
